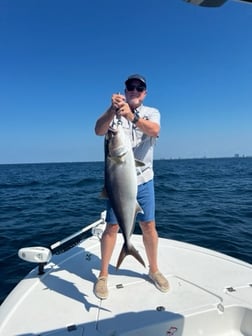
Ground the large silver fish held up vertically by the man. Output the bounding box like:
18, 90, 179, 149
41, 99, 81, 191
105, 121, 145, 268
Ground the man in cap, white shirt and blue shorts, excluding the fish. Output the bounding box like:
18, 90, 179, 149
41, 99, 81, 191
94, 74, 169, 299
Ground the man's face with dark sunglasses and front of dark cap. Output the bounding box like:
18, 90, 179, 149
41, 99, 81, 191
125, 79, 147, 108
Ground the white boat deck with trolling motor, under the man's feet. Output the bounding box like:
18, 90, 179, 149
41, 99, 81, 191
0, 212, 252, 336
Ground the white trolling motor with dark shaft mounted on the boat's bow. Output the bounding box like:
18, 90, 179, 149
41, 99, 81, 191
18, 211, 106, 275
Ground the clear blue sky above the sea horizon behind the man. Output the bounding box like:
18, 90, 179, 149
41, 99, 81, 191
0, 0, 252, 164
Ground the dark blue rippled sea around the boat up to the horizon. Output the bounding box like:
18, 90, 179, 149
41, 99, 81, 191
0, 158, 252, 303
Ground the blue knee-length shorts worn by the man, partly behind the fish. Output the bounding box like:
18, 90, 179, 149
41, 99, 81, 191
106, 180, 155, 224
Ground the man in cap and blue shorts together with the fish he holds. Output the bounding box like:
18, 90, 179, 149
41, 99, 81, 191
94, 74, 169, 299
